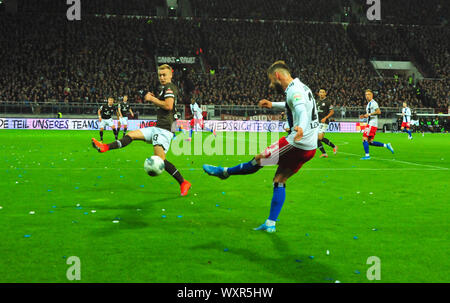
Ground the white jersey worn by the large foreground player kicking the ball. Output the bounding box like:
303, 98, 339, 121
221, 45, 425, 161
285, 78, 319, 150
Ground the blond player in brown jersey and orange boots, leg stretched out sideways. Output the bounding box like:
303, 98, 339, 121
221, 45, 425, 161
92, 64, 191, 196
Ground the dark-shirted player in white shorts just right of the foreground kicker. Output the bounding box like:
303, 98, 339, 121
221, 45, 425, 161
317, 89, 338, 158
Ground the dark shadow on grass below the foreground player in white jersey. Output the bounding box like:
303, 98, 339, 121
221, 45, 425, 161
192, 232, 337, 283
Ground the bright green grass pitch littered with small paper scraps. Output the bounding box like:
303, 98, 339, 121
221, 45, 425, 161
0, 130, 450, 283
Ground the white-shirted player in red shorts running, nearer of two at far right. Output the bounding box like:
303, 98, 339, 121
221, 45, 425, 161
359, 89, 394, 160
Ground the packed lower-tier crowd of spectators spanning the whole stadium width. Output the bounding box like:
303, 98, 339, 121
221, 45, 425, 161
0, 6, 449, 113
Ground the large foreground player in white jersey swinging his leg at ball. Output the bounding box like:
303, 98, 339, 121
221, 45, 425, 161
203, 61, 319, 232
